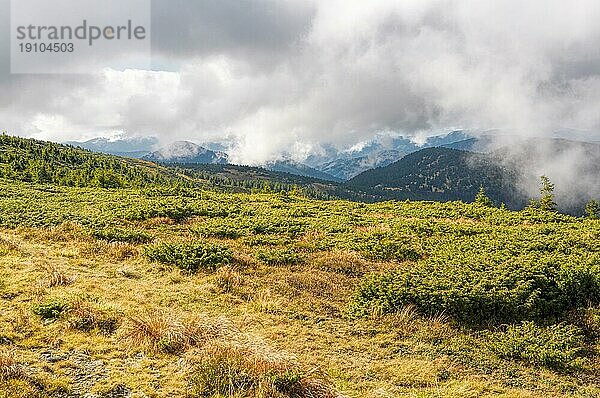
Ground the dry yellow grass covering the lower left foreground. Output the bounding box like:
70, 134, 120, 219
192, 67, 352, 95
0, 223, 600, 398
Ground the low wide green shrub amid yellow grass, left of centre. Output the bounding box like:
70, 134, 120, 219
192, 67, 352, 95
144, 242, 233, 272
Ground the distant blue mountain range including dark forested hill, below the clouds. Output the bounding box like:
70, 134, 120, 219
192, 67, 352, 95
61, 131, 600, 213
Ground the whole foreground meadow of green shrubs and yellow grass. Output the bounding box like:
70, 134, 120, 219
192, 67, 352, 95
0, 135, 600, 398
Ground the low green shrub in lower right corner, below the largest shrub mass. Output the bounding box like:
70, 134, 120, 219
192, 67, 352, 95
488, 322, 585, 370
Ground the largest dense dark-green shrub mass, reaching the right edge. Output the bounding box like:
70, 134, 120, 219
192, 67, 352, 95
350, 253, 600, 324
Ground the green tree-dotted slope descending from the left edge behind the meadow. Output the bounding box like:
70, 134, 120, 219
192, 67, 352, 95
0, 135, 349, 199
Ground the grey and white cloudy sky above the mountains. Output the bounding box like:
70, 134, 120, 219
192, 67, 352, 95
0, 0, 600, 162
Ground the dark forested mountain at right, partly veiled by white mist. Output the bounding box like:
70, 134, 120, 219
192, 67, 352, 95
346, 139, 600, 214
